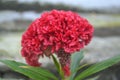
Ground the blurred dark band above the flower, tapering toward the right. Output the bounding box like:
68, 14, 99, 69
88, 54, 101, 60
0, 0, 99, 13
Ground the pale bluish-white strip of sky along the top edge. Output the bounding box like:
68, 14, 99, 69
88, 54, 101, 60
19, 0, 120, 8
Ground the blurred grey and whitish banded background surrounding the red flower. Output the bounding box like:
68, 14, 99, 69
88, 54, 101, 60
0, 0, 120, 80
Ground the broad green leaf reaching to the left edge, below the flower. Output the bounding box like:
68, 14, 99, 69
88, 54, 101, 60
0, 60, 57, 80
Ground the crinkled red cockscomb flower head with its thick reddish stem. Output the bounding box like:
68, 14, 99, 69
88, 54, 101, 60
21, 10, 93, 76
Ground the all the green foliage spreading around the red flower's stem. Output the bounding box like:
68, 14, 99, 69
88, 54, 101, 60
0, 52, 120, 80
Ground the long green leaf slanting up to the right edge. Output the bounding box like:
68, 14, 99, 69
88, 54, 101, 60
75, 55, 120, 80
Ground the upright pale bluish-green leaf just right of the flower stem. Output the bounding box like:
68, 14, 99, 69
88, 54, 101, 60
70, 51, 84, 80
